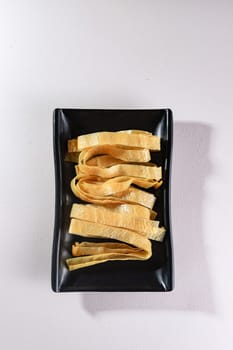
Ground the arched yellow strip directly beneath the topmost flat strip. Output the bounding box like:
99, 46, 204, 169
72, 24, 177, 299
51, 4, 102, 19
78, 144, 151, 164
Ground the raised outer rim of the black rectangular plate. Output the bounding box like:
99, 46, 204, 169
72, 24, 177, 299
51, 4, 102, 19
51, 108, 174, 293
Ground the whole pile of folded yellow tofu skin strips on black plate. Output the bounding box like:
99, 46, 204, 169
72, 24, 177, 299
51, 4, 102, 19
65, 130, 166, 271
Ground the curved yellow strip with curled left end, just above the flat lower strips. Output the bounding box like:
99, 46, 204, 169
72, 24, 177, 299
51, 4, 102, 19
71, 177, 156, 209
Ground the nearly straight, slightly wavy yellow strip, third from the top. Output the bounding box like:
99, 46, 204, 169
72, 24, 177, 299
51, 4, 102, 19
75, 163, 162, 181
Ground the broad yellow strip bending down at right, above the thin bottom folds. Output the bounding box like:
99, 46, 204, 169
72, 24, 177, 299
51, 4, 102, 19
69, 219, 151, 254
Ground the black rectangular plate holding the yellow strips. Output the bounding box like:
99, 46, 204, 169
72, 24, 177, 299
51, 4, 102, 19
52, 109, 173, 292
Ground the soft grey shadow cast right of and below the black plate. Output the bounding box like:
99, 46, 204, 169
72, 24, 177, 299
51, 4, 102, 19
82, 122, 215, 314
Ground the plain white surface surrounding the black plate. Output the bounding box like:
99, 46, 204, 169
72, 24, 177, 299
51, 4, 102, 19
0, 0, 233, 350
